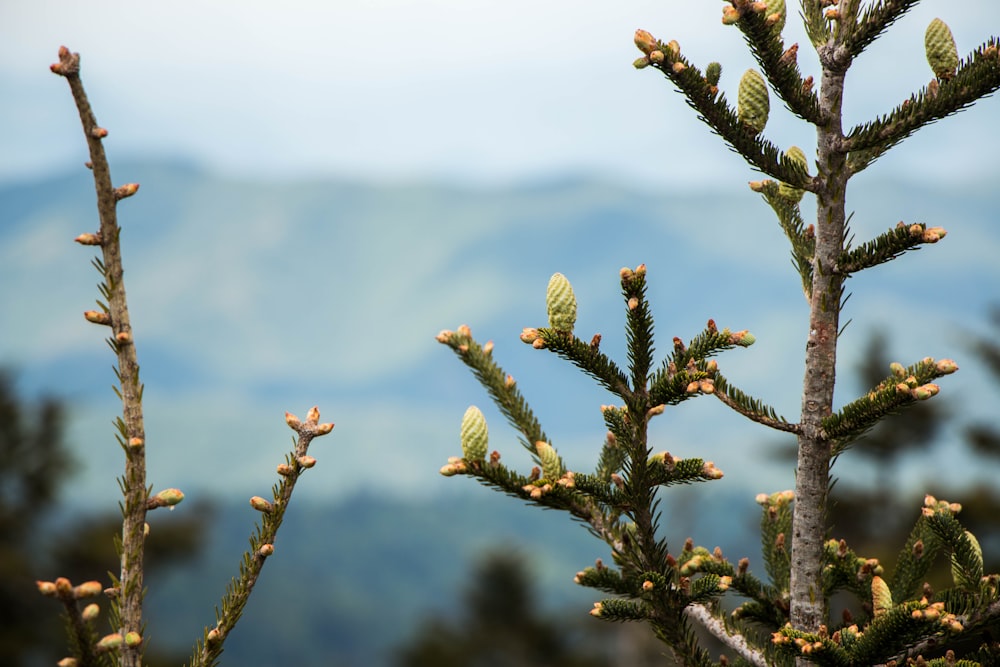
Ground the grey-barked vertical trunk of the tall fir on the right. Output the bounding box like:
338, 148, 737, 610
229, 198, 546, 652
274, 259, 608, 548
790, 40, 849, 632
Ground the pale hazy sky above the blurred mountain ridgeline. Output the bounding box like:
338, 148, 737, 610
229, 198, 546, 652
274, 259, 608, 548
0, 0, 1000, 188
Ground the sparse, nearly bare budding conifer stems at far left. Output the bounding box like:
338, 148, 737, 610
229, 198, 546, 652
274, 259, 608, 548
38, 47, 333, 667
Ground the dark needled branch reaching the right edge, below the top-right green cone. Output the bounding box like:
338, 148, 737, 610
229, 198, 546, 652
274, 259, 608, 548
844, 37, 1000, 173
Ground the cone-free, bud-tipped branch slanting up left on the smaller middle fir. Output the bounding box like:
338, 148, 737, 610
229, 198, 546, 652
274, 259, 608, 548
437, 325, 548, 461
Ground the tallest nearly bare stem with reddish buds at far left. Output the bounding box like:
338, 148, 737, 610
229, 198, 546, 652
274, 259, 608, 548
50, 46, 148, 667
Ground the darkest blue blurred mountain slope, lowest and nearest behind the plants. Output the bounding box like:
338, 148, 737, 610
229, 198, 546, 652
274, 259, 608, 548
137, 480, 760, 667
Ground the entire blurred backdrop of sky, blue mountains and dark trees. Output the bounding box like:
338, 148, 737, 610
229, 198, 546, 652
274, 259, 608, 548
0, 0, 1000, 665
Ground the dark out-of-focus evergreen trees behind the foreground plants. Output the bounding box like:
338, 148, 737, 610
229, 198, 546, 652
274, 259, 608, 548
0, 308, 1000, 667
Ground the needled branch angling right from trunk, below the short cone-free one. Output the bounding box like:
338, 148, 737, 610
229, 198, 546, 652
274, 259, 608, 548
822, 357, 958, 448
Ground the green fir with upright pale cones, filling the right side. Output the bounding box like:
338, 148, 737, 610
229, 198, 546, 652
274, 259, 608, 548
438, 5, 1000, 665
